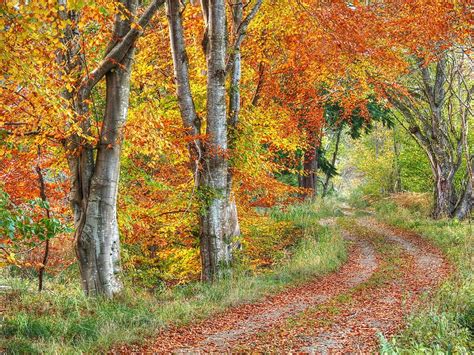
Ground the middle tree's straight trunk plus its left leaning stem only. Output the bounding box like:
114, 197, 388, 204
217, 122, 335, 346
167, 0, 231, 281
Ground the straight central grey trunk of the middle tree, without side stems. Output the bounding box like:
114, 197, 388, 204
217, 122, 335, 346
199, 0, 231, 281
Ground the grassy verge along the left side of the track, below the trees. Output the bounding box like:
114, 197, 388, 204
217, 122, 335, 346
0, 205, 346, 354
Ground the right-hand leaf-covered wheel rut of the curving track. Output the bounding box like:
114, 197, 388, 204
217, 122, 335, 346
298, 218, 449, 354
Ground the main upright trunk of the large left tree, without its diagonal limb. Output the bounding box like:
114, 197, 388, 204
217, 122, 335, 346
76, 0, 137, 298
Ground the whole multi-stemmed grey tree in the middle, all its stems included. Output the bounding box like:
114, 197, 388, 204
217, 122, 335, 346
167, 0, 262, 281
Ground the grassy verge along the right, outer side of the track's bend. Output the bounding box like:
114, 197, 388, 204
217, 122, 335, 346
376, 201, 474, 354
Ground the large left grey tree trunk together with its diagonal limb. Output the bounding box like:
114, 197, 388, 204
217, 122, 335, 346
60, 0, 164, 298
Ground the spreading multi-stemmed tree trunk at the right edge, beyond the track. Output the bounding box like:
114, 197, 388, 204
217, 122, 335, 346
388, 50, 473, 219
